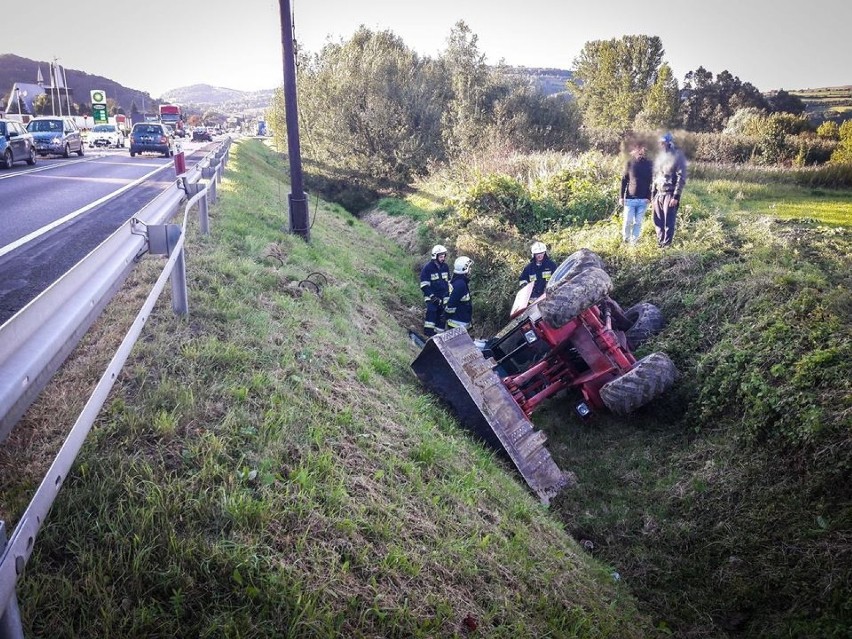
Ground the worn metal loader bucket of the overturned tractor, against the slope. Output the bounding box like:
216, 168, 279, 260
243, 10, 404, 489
411, 328, 568, 504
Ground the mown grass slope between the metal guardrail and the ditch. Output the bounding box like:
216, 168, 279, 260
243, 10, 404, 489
0, 141, 654, 638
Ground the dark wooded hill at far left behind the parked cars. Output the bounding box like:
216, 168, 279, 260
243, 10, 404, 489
0, 53, 156, 113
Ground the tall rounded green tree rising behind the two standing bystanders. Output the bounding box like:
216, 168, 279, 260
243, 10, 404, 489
568, 35, 664, 131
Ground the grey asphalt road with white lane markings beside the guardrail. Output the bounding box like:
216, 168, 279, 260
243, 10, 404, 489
0, 143, 211, 324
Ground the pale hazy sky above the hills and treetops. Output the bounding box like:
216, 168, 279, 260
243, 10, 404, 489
0, 0, 852, 98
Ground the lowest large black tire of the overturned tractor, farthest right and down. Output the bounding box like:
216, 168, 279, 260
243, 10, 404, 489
601, 353, 677, 415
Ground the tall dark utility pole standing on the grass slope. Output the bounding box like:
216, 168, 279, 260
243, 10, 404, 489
278, 0, 311, 242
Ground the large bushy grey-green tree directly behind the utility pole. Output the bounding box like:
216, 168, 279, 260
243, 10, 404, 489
286, 26, 448, 184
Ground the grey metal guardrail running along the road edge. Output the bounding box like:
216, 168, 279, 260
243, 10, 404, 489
0, 138, 230, 639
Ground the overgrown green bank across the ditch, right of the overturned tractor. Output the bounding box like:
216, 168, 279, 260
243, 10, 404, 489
380, 158, 852, 637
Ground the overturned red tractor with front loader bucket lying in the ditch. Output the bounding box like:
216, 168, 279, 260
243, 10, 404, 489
411, 249, 677, 503
